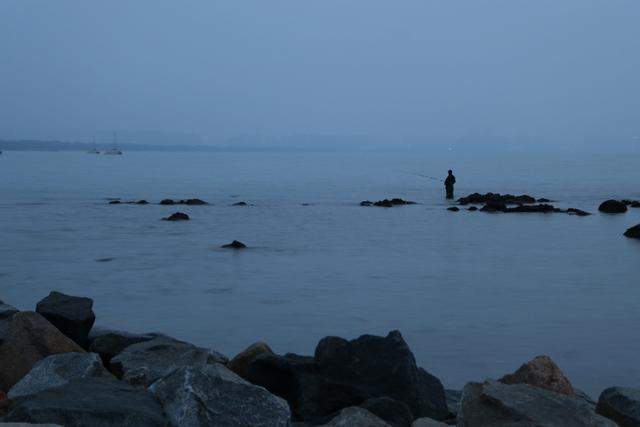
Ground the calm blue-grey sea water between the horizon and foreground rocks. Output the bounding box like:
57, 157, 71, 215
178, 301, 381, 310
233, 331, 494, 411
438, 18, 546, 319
0, 151, 640, 395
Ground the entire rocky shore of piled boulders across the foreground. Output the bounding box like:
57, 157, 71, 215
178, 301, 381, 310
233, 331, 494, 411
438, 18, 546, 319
0, 292, 640, 427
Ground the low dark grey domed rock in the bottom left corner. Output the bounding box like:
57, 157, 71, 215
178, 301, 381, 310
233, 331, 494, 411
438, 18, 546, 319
3, 378, 168, 427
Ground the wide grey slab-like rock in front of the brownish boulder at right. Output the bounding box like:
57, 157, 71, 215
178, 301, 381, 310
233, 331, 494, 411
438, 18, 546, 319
458, 381, 615, 427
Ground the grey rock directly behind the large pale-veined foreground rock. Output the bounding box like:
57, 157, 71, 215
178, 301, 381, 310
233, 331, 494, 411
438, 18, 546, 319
111, 335, 228, 387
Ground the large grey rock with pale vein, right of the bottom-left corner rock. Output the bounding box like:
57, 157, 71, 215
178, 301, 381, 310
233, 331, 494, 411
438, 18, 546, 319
149, 364, 291, 427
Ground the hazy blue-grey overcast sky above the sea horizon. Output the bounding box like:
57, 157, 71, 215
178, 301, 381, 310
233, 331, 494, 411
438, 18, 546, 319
0, 0, 640, 144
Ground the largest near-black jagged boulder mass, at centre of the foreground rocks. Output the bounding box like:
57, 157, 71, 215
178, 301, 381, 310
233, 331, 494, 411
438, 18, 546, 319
249, 331, 449, 420
